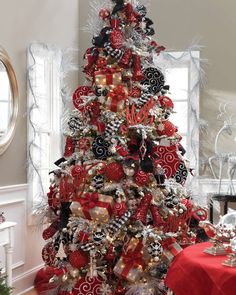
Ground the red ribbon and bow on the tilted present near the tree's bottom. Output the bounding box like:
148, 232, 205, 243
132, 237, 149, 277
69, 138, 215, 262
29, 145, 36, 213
121, 241, 146, 279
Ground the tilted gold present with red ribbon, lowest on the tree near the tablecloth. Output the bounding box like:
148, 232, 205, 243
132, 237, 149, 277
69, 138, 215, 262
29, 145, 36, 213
113, 238, 146, 283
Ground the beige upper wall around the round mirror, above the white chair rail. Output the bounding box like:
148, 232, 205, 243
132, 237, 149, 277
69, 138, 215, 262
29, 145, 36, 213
0, 0, 79, 186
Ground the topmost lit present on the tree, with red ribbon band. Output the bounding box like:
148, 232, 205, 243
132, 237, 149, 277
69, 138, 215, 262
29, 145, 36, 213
94, 69, 122, 86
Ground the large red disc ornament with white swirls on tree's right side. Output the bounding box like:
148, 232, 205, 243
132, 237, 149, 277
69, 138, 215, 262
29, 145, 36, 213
152, 145, 179, 178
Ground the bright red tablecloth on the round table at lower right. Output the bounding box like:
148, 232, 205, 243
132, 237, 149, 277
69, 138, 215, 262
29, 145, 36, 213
166, 243, 236, 295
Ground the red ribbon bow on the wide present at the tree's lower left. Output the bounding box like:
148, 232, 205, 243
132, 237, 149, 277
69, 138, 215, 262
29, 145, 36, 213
78, 192, 112, 220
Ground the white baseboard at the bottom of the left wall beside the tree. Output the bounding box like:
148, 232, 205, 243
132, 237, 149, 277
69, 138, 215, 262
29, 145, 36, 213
13, 264, 44, 295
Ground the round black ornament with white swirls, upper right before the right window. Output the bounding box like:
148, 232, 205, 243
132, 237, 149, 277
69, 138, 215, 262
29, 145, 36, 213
141, 67, 165, 94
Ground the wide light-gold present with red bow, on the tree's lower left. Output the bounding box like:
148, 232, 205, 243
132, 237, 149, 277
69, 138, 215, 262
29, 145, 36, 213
70, 192, 113, 223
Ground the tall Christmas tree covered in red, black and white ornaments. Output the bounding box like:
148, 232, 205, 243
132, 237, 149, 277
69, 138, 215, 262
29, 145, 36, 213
42, 0, 206, 295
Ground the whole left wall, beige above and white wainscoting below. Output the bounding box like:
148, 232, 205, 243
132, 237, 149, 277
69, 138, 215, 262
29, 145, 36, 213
0, 0, 79, 295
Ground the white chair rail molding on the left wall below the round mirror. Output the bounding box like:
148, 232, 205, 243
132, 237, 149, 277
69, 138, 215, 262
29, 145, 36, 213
0, 183, 28, 206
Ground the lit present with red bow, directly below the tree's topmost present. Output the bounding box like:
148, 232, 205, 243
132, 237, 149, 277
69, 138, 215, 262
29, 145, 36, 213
106, 85, 127, 112
